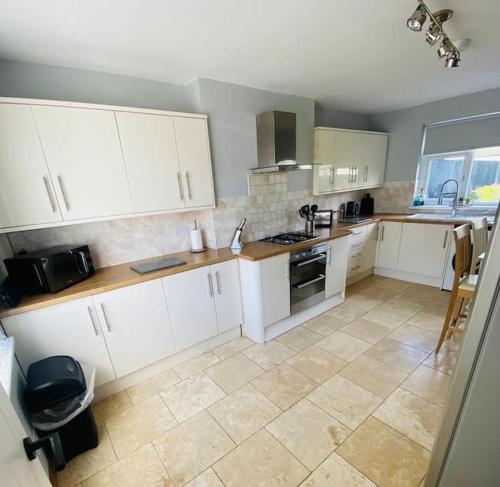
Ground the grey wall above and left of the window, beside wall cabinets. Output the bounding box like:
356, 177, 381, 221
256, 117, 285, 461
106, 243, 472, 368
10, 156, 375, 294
372, 88, 500, 181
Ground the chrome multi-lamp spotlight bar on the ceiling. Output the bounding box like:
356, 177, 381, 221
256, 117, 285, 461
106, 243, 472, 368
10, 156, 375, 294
406, 0, 460, 68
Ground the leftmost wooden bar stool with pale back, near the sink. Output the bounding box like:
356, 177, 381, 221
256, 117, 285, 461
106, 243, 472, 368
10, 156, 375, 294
436, 224, 478, 353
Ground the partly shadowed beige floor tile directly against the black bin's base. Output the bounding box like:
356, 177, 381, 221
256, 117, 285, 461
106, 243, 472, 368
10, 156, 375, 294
57, 423, 116, 487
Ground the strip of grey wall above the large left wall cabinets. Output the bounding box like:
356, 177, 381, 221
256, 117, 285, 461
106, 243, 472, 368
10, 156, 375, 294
0, 59, 198, 112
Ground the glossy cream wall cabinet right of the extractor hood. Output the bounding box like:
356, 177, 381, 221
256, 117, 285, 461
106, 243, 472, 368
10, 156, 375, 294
313, 127, 388, 195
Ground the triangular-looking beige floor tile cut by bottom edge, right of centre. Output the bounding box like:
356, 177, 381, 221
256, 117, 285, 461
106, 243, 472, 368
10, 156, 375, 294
300, 453, 376, 487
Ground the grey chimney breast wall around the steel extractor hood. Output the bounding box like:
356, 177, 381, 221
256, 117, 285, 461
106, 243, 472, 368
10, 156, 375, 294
198, 79, 314, 197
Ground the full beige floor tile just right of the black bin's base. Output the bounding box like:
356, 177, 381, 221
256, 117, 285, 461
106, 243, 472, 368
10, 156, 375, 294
106, 396, 177, 458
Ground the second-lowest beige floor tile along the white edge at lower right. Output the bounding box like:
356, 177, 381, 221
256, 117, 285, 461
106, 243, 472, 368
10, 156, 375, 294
373, 389, 442, 451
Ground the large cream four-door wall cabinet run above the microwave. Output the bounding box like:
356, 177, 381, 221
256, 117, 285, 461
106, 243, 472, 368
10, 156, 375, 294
0, 98, 215, 232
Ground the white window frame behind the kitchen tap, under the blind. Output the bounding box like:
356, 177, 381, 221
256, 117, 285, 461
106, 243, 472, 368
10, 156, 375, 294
415, 150, 499, 207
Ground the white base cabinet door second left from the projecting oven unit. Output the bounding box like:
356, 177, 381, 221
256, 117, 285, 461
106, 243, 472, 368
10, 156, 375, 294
162, 267, 218, 351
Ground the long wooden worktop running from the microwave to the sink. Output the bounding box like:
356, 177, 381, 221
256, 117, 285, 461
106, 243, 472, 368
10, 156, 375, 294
0, 214, 492, 319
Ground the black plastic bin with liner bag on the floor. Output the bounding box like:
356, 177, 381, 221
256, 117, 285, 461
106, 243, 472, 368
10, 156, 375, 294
24, 355, 99, 462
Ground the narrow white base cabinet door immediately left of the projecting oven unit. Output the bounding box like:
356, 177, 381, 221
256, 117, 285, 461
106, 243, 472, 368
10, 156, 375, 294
210, 259, 243, 333
